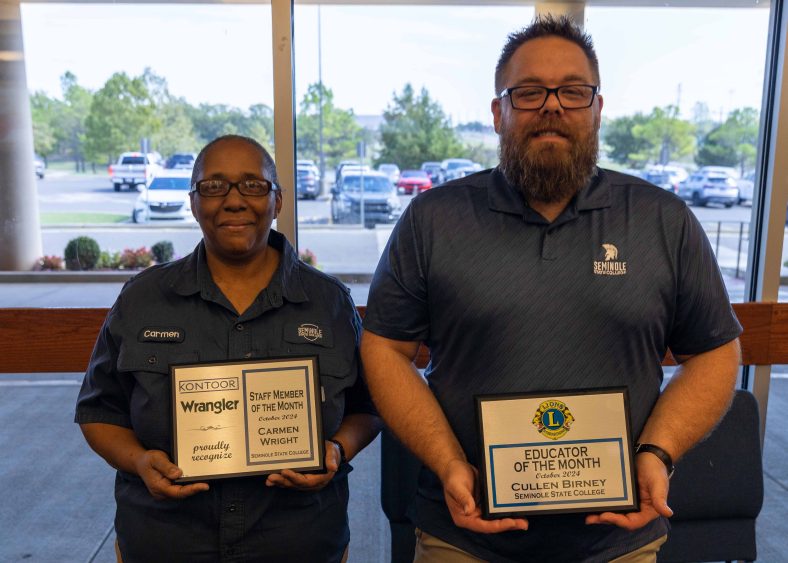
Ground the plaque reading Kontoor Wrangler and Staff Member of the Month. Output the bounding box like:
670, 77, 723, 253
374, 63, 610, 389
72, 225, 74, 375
170, 356, 325, 482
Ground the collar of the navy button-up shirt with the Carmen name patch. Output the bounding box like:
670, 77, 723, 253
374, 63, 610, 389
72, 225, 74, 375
167, 229, 309, 306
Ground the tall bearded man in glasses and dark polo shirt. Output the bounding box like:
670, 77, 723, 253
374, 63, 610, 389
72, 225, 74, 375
362, 17, 741, 561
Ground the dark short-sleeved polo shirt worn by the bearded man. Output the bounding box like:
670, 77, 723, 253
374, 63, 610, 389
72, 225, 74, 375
364, 169, 741, 561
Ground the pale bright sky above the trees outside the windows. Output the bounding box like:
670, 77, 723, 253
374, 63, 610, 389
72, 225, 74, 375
22, 4, 769, 124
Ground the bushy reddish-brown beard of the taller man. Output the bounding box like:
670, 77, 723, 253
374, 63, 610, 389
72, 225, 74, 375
499, 120, 599, 203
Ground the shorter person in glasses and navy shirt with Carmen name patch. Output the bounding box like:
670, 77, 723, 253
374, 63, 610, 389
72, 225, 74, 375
76, 136, 379, 563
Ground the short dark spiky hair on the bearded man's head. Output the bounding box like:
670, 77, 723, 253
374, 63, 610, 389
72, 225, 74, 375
495, 14, 600, 96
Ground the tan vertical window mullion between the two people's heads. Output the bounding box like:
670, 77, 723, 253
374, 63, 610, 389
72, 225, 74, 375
271, 0, 298, 248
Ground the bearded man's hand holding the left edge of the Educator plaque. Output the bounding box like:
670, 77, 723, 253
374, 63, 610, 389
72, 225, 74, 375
441, 459, 528, 534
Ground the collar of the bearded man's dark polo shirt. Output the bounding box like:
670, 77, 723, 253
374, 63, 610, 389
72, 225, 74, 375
488, 166, 612, 217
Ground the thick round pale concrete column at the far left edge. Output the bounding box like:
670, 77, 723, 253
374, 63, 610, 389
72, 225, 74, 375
0, 0, 42, 270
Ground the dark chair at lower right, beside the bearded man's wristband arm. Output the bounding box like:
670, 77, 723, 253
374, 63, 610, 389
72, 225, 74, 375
657, 391, 763, 563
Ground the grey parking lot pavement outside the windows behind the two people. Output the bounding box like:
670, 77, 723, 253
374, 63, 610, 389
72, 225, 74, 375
32, 171, 776, 288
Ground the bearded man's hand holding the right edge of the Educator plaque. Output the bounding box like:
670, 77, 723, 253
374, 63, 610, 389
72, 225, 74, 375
586, 453, 673, 530
